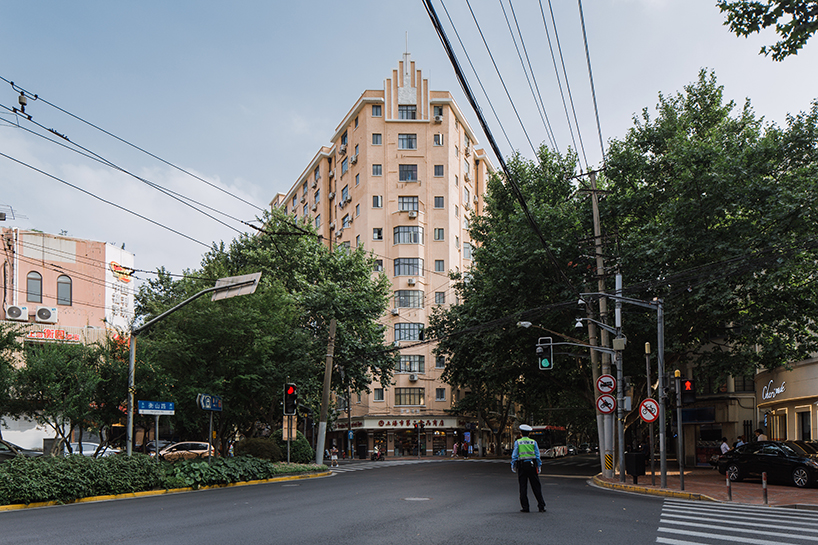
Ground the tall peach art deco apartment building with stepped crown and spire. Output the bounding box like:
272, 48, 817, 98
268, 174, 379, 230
271, 53, 493, 457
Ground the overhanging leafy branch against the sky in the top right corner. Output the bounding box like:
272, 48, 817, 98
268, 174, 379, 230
716, 0, 818, 61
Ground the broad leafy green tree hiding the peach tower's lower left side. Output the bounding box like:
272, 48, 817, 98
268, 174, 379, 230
137, 212, 394, 450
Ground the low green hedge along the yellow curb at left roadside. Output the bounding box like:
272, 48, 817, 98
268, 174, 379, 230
0, 454, 326, 505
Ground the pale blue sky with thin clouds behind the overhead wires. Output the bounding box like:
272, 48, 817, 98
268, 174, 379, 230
0, 0, 818, 279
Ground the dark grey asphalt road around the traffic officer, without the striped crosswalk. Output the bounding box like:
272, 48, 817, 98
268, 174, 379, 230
0, 457, 662, 545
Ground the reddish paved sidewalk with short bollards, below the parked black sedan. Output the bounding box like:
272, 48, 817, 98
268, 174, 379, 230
594, 467, 818, 510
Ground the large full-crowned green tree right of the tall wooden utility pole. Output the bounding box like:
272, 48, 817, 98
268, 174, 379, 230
602, 71, 818, 384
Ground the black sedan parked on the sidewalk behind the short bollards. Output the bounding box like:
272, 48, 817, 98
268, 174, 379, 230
718, 441, 818, 488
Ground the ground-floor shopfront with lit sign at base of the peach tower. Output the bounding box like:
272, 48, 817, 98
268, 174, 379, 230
326, 415, 491, 459
